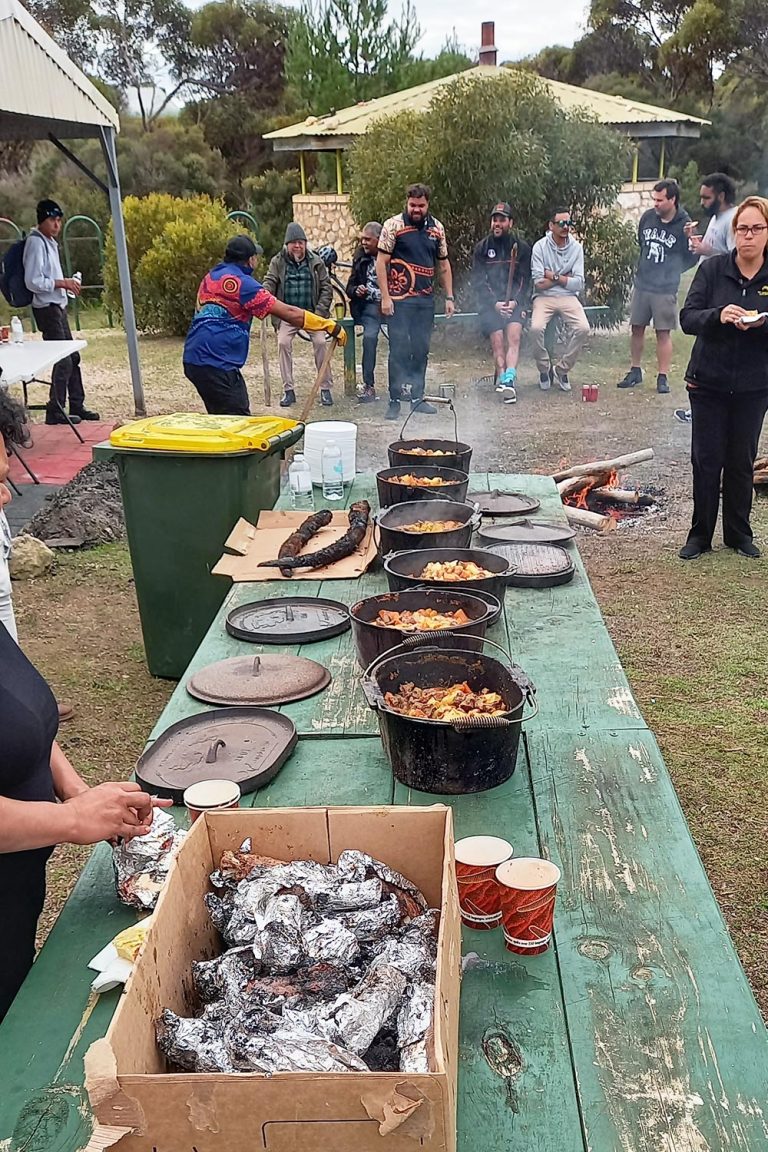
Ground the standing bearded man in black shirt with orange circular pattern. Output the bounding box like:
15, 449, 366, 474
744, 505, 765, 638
377, 184, 455, 420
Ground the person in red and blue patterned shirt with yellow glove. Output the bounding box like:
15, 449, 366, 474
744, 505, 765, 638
183, 236, 347, 416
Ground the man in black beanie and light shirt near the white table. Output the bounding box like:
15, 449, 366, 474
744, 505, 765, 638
24, 200, 99, 424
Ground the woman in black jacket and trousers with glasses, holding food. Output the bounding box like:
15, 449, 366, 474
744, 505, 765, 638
679, 196, 768, 560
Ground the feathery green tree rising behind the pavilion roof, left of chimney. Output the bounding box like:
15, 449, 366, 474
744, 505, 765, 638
287, 0, 421, 115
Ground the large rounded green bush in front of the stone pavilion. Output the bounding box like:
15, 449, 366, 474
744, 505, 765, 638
349, 71, 632, 318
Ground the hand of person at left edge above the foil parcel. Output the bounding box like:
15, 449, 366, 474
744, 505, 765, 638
61, 780, 172, 844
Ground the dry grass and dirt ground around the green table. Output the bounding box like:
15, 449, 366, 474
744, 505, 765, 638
15, 313, 768, 1016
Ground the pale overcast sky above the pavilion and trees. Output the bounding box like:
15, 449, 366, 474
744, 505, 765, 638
279, 0, 588, 63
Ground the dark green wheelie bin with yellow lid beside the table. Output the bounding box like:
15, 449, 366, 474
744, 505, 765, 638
93, 412, 304, 680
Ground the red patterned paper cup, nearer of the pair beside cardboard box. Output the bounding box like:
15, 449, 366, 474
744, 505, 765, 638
496, 856, 561, 956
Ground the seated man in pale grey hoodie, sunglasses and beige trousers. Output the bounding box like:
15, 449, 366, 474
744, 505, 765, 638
531, 209, 590, 392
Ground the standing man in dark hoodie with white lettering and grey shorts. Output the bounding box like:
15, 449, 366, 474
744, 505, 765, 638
617, 180, 699, 393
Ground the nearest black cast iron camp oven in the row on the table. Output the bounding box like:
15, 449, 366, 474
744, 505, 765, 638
363, 636, 538, 796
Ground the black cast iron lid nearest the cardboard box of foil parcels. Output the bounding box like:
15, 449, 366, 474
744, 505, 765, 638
136, 707, 298, 804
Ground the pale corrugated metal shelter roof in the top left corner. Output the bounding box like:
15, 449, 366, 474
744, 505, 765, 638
0, 0, 120, 139
